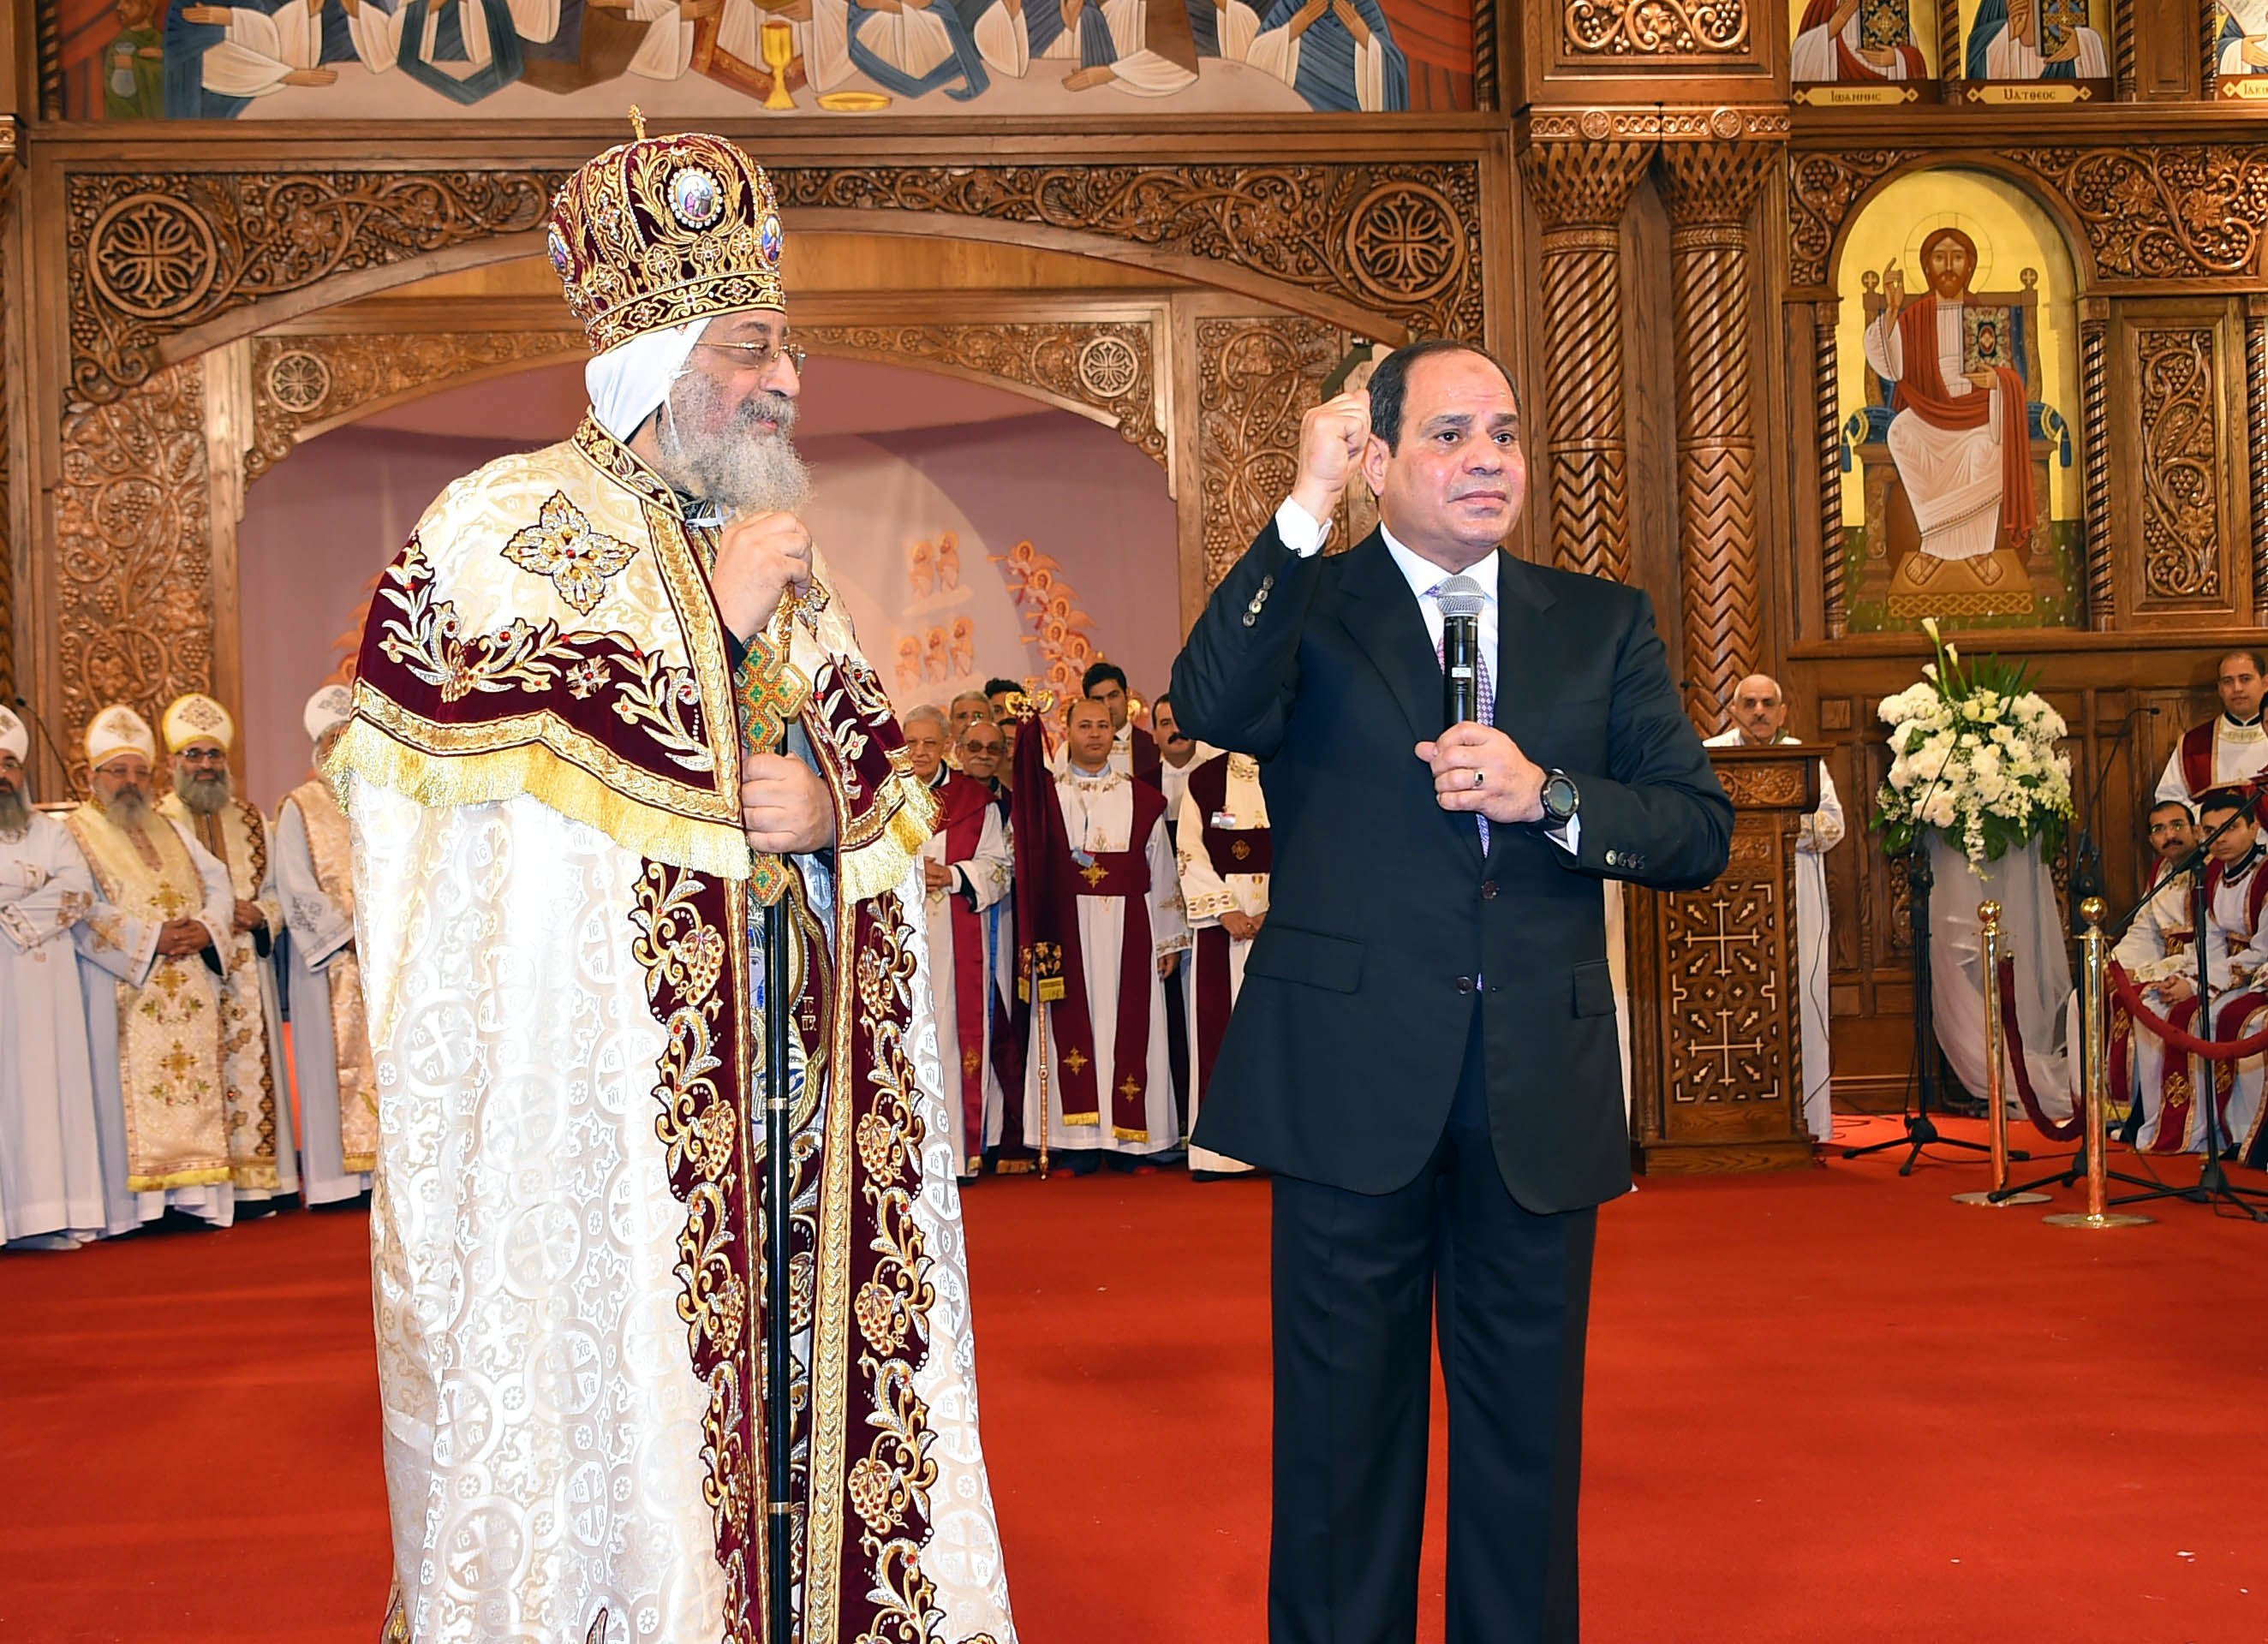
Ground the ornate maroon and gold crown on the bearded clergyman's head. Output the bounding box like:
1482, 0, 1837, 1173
546, 109, 787, 354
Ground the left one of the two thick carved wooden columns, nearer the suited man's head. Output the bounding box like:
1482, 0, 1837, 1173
1519, 143, 1653, 583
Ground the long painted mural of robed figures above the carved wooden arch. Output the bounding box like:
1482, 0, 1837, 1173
41, 0, 1477, 120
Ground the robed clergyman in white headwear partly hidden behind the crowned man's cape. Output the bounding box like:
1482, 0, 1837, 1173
274, 685, 379, 1204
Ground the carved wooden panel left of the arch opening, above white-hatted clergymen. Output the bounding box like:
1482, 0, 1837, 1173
50, 360, 213, 751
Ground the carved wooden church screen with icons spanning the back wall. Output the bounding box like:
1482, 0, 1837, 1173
13, 0, 2268, 1102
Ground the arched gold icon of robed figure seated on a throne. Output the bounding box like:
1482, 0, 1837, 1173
1837, 168, 2082, 633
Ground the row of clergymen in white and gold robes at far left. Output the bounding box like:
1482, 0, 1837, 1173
0, 685, 379, 1249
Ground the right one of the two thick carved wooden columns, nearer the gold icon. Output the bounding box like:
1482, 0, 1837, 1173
1662, 143, 1778, 700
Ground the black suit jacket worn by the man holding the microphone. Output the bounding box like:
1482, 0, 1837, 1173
1173, 524, 1733, 1211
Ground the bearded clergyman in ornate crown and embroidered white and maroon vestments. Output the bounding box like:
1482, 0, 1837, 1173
325, 122, 1014, 1644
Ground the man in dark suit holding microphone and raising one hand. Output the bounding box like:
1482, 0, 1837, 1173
1173, 342, 1733, 1644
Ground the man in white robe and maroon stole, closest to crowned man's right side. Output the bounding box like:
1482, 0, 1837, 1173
898, 707, 1016, 1179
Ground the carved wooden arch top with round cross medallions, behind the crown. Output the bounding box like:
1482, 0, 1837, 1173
66, 161, 1483, 403
